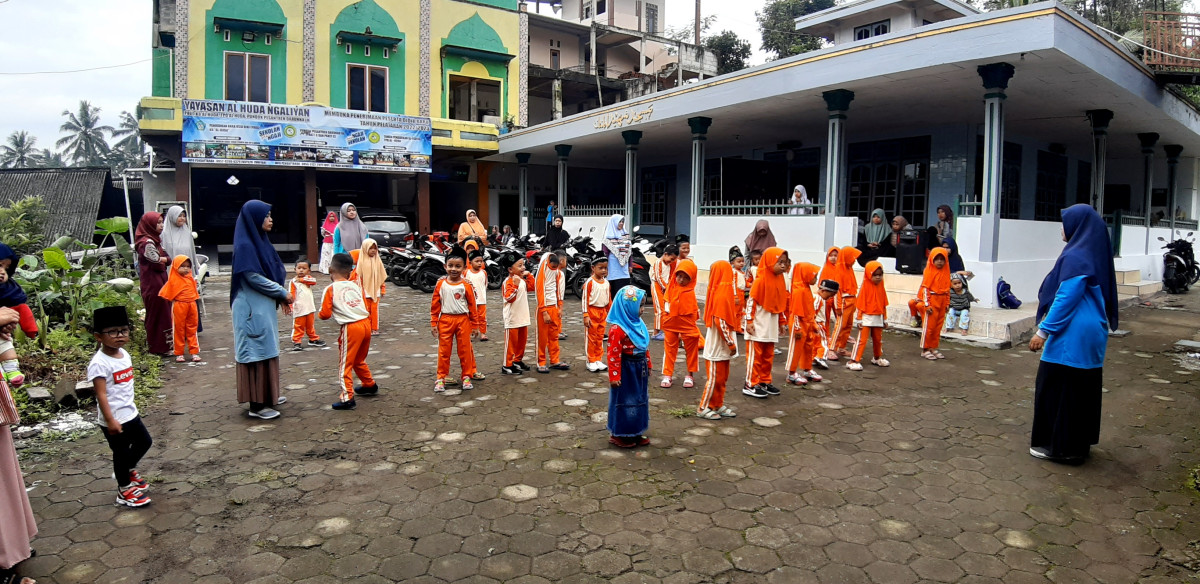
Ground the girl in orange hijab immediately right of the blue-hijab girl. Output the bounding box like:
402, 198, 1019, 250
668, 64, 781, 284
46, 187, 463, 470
661, 259, 704, 387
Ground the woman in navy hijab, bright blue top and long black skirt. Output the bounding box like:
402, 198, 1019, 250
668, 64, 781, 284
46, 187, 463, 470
1030, 204, 1117, 464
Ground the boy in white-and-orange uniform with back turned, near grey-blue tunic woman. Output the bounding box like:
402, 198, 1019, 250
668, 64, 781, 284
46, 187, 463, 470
317, 253, 379, 410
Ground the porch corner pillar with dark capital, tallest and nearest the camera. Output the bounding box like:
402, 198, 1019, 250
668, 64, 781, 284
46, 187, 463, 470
977, 62, 1015, 261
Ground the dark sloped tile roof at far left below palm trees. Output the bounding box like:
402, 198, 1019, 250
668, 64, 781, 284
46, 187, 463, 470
0, 167, 112, 242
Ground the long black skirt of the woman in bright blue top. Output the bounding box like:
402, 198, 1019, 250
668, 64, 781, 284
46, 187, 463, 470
1030, 361, 1104, 458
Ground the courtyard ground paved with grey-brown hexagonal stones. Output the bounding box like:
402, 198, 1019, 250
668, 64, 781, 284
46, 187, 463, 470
9, 277, 1200, 584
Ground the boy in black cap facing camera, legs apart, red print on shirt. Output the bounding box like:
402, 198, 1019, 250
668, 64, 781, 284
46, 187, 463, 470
430, 247, 485, 393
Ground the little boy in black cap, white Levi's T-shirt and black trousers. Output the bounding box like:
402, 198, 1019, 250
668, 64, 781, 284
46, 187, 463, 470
88, 306, 154, 507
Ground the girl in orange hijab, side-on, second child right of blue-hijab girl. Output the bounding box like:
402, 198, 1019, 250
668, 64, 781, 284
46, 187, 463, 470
696, 260, 742, 420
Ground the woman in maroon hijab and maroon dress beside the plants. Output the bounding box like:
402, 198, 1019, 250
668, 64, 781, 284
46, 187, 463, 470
133, 211, 170, 355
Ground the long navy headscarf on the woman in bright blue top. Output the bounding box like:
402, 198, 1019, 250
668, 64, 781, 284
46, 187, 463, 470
1037, 203, 1117, 330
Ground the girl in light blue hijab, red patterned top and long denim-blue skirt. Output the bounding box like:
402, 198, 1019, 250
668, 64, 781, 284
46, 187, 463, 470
607, 285, 653, 448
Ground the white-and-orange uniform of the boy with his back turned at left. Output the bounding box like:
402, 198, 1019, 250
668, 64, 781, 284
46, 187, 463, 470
318, 279, 374, 402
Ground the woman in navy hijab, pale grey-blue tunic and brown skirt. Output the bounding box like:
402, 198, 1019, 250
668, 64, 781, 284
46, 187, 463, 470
229, 200, 294, 420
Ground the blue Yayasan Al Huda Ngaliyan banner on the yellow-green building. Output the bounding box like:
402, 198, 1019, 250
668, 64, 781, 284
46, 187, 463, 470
182, 100, 433, 173
